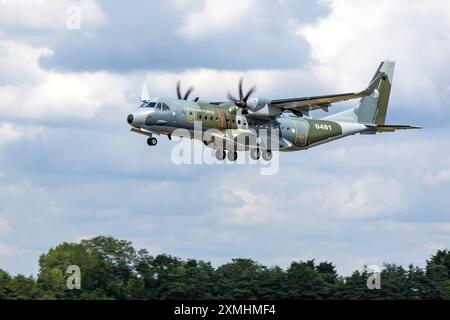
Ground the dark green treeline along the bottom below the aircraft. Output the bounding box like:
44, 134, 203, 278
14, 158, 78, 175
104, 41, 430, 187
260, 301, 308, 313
0, 237, 450, 299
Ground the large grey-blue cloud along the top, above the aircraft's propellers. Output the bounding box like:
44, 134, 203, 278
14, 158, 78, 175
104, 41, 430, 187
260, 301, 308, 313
32, 0, 328, 72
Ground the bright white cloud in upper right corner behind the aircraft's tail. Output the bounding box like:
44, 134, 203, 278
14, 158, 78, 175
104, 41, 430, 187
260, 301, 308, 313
298, 0, 450, 123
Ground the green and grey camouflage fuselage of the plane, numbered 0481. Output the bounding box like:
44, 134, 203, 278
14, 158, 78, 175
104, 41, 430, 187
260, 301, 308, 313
128, 98, 367, 151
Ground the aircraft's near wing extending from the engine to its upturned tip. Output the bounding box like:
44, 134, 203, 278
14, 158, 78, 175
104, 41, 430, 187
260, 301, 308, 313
270, 73, 386, 115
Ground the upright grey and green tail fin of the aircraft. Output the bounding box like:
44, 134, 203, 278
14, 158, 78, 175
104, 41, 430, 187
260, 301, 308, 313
357, 61, 395, 125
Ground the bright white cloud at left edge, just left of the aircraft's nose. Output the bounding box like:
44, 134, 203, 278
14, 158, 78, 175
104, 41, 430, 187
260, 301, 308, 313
0, 41, 133, 121
